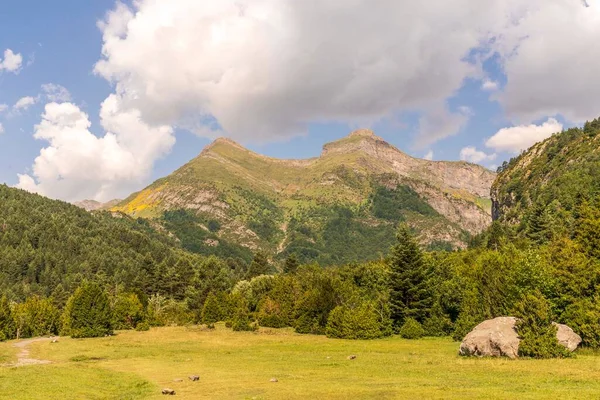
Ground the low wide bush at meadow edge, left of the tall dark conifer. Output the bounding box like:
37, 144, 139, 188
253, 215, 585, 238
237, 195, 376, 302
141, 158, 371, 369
325, 303, 385, 339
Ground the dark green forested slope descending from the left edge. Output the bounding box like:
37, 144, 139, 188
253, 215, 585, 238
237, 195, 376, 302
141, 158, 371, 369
0, 185, 209, 301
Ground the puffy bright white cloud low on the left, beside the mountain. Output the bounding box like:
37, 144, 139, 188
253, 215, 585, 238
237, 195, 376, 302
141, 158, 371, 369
17, 95, 175, 201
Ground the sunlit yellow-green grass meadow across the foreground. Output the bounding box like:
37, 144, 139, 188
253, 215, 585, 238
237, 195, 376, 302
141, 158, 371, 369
0, 326, 600, 400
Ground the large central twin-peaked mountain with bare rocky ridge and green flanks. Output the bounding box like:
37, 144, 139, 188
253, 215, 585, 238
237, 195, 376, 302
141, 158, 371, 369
112, 129, 495, 264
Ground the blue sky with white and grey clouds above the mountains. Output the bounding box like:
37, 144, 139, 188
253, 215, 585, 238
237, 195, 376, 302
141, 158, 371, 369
0, 0, 600, 200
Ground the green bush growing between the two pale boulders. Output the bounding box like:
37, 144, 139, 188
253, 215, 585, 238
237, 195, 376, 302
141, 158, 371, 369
514, 292, 571, 358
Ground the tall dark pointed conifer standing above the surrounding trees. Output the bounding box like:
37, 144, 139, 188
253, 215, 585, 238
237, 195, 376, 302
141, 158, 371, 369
390, 224, 432, 327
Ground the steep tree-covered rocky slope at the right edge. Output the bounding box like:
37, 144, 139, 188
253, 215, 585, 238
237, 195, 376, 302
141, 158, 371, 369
492, 115, 600, 242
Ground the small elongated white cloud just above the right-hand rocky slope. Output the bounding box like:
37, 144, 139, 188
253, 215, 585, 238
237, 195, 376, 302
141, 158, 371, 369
485, 118, 563, 153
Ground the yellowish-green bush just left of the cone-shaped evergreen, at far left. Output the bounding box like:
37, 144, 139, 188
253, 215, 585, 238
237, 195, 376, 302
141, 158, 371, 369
13, 296, 60, 337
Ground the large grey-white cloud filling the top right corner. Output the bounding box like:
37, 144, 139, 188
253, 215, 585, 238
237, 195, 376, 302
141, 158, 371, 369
496, 0, 600, 123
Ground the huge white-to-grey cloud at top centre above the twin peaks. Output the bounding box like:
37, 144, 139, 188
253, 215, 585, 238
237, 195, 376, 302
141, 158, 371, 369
95, 0, 520, 143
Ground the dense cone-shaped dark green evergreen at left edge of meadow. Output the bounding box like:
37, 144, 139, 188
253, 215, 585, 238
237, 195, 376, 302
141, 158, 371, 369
64, 282, 113, 338
